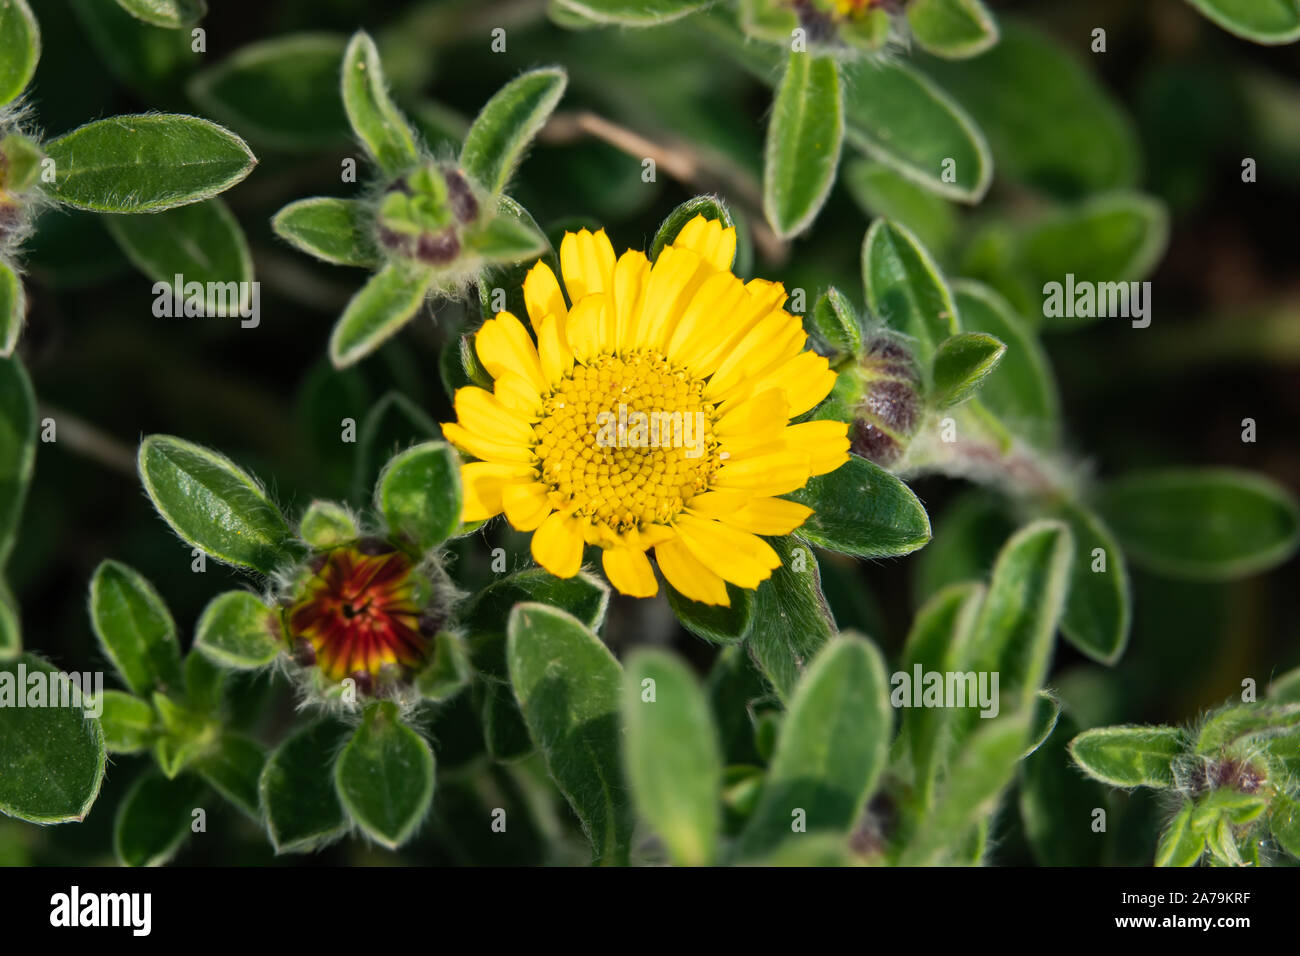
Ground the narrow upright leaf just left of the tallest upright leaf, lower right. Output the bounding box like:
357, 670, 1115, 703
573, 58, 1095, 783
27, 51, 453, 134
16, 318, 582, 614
900, 581, 984, 808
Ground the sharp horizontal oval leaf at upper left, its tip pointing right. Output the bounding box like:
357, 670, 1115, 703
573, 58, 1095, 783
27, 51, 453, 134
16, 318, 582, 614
46, 113, 257, 212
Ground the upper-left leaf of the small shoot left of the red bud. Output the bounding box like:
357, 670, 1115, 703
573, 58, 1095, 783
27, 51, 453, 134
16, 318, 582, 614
90, 561, 185, 697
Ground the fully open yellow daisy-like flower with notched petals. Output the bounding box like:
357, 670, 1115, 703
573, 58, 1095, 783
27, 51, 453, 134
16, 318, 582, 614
442, 216, 849, 605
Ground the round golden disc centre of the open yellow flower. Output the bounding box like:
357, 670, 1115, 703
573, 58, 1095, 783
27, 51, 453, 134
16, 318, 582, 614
533, 351, 722, 532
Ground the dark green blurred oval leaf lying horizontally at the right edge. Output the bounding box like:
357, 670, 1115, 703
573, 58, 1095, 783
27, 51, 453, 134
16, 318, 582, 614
1097, 468, 1300, 580
